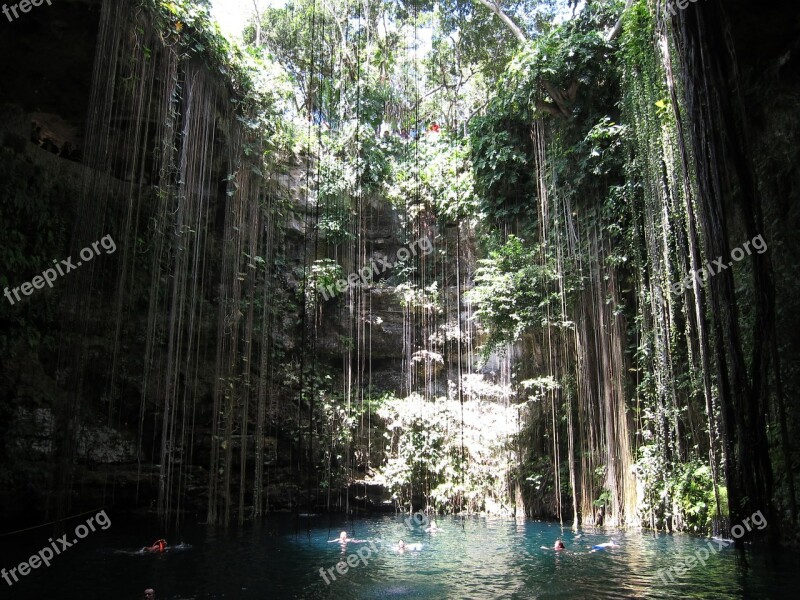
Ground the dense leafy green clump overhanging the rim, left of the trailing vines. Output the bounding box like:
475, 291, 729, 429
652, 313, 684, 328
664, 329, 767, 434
471, 3, 619, 226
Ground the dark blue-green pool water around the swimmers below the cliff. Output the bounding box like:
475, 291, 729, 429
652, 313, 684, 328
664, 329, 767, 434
0, 515, 800, 600
